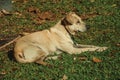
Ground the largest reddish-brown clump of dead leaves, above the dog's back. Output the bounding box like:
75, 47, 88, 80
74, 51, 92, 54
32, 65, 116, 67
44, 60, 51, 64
27, 6, 56, 25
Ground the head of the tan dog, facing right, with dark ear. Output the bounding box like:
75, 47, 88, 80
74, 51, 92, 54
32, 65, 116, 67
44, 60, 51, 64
61, 12, 87, 35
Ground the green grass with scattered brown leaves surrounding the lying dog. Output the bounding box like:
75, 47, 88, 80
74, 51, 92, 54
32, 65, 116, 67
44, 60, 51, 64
0, 0, 120, 80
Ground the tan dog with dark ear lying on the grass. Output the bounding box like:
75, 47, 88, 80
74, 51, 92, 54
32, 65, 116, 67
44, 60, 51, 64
14, 12, 107, 65
